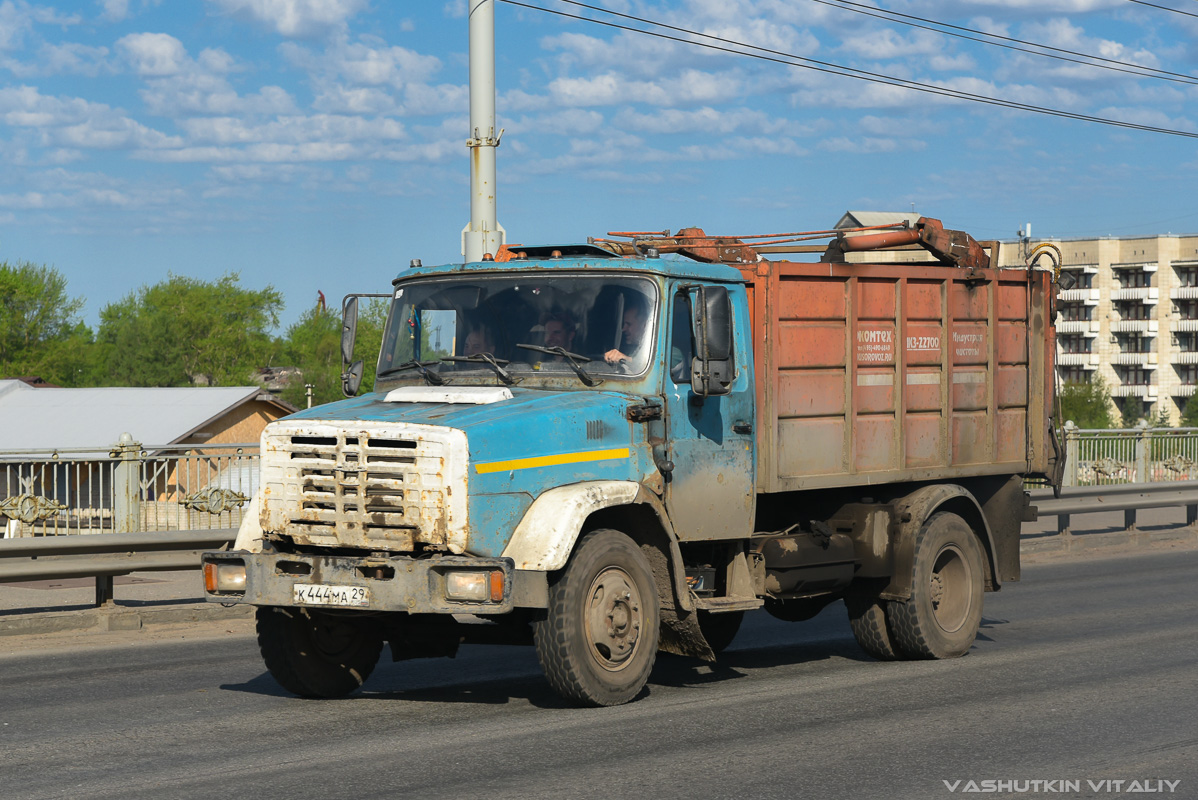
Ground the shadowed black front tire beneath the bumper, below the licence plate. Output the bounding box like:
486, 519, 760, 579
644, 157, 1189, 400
258, 606, 382, 697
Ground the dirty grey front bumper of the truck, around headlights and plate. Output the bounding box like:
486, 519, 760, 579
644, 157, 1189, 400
202, 551, 531, 614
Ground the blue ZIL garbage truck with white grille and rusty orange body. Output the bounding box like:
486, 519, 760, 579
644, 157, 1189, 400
204, 218, 1063, 705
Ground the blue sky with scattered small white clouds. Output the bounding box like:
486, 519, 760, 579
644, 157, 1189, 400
0, 0, 1198, 325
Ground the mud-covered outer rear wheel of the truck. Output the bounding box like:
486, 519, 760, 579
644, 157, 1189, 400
887, 511, 985, 659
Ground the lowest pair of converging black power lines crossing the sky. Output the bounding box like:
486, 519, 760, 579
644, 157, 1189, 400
500, 0, 1198, 139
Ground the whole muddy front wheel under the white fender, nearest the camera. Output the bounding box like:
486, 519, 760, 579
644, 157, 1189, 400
533, 529, 660, 707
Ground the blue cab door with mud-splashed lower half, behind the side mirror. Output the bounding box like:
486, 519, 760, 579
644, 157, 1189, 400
662, 285, 756, 541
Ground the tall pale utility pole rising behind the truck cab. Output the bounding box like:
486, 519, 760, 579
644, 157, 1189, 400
461, 0, 504, 261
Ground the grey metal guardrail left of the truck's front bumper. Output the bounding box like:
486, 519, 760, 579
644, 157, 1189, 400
0, 529, 237, 606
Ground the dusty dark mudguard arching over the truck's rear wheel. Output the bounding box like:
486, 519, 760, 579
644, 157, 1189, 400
882, 484, 999, 600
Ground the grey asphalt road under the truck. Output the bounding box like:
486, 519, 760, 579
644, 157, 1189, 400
0, 550, 1198, 800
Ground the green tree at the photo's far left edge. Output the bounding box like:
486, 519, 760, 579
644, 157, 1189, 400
0, 261, 97, 386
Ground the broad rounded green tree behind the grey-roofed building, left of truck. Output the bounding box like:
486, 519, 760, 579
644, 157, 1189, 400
96, 273, 283, 386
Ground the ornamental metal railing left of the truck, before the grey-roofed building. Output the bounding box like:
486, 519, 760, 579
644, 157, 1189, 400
0, 434, 259, 539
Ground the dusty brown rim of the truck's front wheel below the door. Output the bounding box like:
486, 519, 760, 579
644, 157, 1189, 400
585, 566, 645, 672
